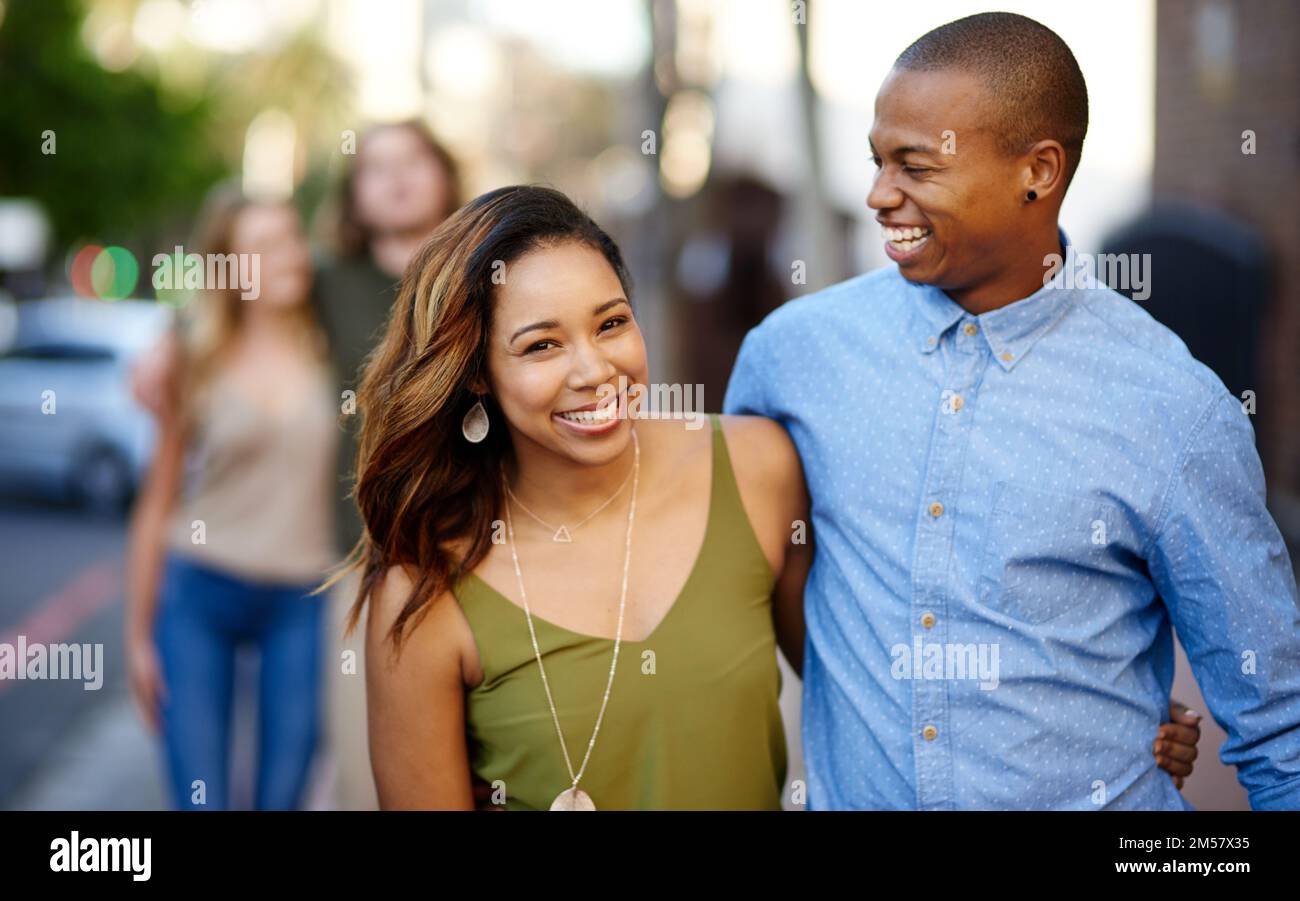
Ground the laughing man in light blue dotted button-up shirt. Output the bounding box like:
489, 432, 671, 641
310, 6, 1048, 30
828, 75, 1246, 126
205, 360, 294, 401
725, 13, 1300, 809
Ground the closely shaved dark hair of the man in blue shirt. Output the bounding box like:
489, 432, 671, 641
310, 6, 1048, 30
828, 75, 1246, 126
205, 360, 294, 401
894, 13, 1088, 185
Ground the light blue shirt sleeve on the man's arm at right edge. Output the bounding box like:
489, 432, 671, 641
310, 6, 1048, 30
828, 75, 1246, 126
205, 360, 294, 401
1148, 390, 1300, 810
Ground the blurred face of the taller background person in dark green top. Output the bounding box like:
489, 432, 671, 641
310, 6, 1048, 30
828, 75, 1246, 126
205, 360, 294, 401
352, 126, 450, 239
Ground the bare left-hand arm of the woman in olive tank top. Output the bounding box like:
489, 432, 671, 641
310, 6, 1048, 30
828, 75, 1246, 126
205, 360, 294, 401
365, 567, 475, 810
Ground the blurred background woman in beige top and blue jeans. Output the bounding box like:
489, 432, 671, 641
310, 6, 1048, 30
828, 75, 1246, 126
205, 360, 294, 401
126, 191, 338, 809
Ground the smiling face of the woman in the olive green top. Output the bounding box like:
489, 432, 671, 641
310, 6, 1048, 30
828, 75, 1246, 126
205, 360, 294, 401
488, 241, 649, 465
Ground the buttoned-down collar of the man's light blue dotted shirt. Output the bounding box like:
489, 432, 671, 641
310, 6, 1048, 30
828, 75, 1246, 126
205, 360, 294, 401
915, 228, 1071, 372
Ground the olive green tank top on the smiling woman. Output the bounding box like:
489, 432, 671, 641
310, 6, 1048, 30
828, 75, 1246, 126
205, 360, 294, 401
454, 415, 787, 810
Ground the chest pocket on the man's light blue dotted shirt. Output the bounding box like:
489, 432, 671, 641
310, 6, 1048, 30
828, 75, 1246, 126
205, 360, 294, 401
980, 482, 1118, 625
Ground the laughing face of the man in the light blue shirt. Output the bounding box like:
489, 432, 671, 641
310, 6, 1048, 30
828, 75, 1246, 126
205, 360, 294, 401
867, 69, 1026, 293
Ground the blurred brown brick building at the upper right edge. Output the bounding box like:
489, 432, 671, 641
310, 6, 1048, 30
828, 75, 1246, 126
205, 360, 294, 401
1153, 0, 1300, 495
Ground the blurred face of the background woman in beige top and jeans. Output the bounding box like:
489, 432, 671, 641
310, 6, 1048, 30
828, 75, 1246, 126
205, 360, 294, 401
230, 204, 312, 307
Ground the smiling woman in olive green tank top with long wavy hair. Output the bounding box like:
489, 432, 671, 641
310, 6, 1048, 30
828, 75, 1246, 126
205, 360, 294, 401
325, 187, 810, 810
